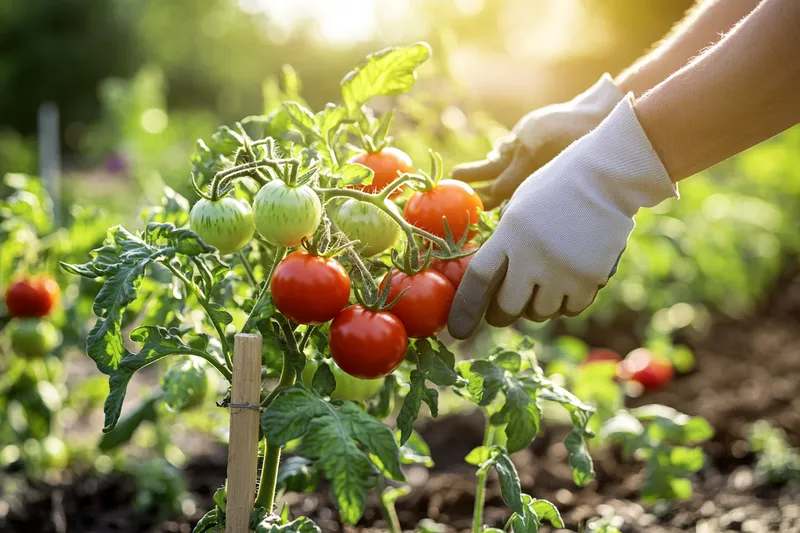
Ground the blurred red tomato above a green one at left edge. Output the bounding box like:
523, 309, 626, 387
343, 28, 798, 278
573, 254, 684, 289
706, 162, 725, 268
5, 275, 61, 357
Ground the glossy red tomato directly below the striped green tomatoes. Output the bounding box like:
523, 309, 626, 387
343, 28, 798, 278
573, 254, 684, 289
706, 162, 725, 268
270, 251, 350, 324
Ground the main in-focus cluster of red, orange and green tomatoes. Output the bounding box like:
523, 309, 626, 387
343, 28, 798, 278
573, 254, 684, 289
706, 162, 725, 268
190, 144, 483, 379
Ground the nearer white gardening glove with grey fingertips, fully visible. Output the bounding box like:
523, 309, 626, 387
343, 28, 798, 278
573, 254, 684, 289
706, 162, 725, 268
448, 96, 678, 339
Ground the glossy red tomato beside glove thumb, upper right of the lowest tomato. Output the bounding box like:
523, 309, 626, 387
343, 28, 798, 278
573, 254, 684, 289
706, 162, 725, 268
381, 269, 456, 339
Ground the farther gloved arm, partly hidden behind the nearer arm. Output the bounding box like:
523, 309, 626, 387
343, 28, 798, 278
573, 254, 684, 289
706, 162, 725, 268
453, 0, 761, 209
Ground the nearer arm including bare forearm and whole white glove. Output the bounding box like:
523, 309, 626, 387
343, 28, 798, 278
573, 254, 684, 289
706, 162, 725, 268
448, 0, 800, 338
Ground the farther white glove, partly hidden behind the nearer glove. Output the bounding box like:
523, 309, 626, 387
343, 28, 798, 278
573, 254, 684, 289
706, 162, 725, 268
453, 74, 624, 209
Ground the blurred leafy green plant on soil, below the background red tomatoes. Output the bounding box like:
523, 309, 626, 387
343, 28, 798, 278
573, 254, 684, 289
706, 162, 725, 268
601, 405, 713, 503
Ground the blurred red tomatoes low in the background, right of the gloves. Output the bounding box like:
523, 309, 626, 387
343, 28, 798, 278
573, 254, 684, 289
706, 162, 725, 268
582, 348, 675, 391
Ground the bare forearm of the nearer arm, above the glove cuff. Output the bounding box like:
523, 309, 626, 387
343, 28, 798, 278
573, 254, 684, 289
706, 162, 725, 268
634, 0, 800, 181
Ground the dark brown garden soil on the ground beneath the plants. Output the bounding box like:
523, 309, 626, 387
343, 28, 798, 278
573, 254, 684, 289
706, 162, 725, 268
0, 270, 800, 533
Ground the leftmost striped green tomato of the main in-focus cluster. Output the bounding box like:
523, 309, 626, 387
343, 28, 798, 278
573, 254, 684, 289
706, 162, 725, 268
189, 196, 254, 255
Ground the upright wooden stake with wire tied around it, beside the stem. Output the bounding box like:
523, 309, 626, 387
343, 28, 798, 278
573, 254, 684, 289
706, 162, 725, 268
225, 333, 262, 533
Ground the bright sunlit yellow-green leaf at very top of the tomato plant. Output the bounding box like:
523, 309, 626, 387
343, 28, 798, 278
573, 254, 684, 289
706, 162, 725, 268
341, 43, 431, 116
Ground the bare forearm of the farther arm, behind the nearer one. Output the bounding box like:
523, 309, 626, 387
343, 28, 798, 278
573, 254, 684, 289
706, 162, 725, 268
615, 0, 761, 97
